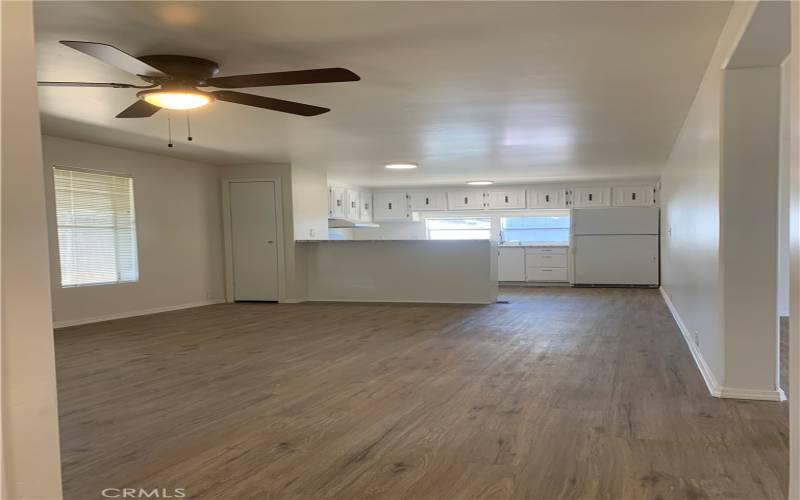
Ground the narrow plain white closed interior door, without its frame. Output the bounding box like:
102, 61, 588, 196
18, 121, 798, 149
229, 181, 278, 301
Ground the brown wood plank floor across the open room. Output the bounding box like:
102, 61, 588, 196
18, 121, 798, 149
56, 288, 788, 500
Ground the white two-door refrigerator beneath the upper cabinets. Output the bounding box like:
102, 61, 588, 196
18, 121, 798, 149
572, 207, 659, 286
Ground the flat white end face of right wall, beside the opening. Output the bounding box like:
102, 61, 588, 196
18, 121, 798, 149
720, 66, 780, 393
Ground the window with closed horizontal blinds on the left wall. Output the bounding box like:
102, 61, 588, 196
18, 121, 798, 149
53, 167, 139, 287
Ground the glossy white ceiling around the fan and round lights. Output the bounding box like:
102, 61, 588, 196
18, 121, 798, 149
35, 2, 730, 186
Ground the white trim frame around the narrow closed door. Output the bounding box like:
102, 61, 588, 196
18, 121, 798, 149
220, 177, 286, 303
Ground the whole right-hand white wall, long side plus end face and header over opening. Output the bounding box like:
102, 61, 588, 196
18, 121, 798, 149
661, 2, 788, 399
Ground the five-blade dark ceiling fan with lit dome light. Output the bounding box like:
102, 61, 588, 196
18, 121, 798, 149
39, 40, 361, 118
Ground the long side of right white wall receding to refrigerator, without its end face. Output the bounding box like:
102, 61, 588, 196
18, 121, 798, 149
661, 3, 756, 390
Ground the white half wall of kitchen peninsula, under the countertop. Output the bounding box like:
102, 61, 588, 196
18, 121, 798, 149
298, 241, 497, 304
